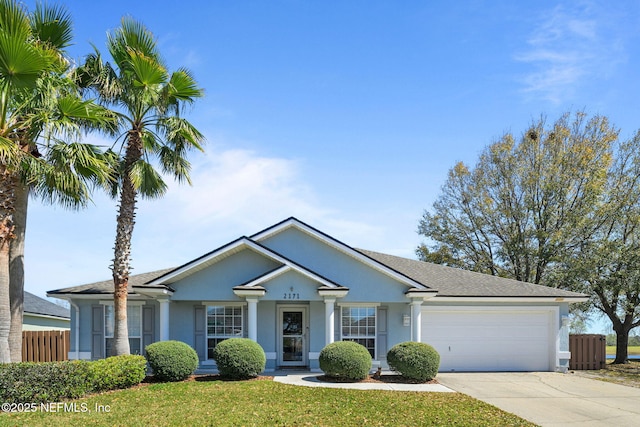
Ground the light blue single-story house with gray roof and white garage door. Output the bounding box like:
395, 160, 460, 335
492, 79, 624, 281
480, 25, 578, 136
48, 218, 586, 372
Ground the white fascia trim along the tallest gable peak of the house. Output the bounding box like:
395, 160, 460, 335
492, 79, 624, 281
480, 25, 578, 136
251, 218, 429, 289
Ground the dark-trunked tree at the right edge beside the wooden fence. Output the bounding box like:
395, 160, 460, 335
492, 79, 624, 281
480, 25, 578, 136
553, 132, 640, 363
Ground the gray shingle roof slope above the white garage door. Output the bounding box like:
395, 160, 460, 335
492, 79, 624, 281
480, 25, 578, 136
357, 249, 585, 298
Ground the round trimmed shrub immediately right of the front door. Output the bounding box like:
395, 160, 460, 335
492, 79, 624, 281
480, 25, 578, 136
319, 341, 371, 381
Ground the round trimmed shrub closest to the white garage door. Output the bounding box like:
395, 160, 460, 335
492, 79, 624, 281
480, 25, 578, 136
387, 341, 440, 381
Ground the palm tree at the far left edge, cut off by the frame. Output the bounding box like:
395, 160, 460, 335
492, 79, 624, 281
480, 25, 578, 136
0, 0, 113, 362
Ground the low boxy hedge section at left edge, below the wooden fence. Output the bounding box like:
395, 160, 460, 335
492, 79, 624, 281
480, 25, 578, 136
0, 360, 93, 403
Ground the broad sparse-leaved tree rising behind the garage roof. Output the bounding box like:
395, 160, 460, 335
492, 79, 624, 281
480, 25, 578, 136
417, 113, 618, 284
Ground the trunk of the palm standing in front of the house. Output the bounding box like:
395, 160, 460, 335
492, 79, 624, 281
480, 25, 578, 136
113, 131, 142, 355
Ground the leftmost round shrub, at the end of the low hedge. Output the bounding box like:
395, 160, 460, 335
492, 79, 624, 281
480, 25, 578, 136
144, 341, 198, 381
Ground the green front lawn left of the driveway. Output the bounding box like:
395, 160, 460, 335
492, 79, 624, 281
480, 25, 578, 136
0, 380, 534, 427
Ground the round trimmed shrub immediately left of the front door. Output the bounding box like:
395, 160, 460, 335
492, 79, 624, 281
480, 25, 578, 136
213, 338, 267, 380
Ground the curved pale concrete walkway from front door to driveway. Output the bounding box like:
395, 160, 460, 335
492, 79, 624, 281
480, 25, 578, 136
271, 371, 453, 393
